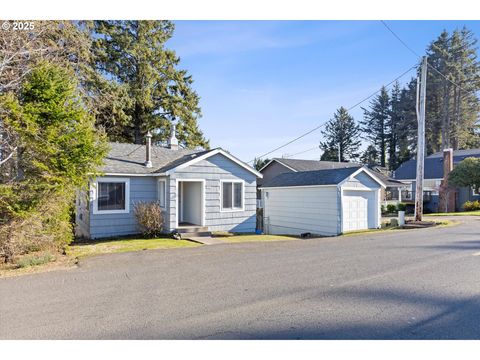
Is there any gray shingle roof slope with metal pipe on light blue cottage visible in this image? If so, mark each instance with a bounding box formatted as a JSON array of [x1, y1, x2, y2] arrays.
[[101, 143, 212, 174]]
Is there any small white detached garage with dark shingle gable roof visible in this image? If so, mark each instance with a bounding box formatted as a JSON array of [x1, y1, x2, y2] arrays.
[[260, 166, 384, 235]]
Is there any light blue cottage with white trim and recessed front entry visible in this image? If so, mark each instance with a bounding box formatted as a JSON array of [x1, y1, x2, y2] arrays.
[[76, 130, 262, 239]]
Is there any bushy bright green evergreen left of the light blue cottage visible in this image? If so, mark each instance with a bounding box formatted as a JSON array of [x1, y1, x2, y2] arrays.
[[0, 62, 108, 261]]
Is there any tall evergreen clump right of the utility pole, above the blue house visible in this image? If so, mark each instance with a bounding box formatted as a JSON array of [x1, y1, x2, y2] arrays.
[[426, 28, 480, 153]]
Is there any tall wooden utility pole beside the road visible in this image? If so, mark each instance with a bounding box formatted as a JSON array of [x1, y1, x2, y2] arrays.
[[415, 56, 427, 221]]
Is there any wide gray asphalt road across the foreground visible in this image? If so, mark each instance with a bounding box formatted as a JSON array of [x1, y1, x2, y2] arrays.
[[0, 217, 480, 339]]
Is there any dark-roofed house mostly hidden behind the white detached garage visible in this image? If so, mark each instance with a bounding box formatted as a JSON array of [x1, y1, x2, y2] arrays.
[[257, 158, 408, 207]]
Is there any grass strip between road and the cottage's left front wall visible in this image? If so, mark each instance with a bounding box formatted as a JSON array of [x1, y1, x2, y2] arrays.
[[67, 238, 201, 257]]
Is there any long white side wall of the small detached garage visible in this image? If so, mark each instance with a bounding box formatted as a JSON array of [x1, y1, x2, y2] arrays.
[[262, 186, 339, 235]]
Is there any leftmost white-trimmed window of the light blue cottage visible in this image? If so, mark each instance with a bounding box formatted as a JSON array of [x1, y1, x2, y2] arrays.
[[93, 178, 130, 214]]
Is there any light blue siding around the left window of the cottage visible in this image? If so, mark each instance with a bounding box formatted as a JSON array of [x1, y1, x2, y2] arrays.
[[90, 176, 158, 239]]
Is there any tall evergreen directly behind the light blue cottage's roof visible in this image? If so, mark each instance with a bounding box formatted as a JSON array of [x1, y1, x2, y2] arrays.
[[93, 21, 209, 148]]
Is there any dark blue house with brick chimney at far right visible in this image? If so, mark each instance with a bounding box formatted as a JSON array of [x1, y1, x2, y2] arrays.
[[393, 149, 480, 212]]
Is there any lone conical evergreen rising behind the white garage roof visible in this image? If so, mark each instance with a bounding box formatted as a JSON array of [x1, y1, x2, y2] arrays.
[[320, 107, 361, 162]]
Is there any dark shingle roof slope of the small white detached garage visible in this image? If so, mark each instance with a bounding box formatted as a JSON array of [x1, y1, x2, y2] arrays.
[[262, 166, 359, 187]]
